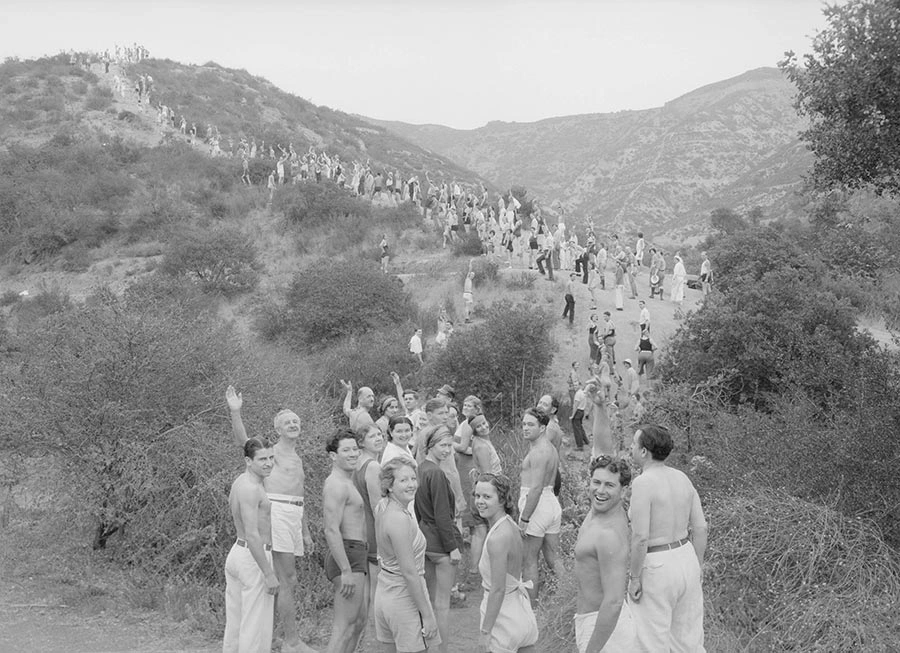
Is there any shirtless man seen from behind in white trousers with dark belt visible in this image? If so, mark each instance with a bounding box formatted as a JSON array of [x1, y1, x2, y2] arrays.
[[628, 424, 707, 653]]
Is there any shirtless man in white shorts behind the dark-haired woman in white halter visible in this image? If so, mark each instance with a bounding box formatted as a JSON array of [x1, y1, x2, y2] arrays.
[[519, 408, 565, 602]]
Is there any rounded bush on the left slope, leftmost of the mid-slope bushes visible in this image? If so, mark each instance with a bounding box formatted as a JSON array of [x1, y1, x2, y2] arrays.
[[160, 225, 263, 295]]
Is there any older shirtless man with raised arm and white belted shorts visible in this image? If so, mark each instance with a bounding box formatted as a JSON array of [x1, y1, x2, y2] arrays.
[[225, 386, 315, 653]]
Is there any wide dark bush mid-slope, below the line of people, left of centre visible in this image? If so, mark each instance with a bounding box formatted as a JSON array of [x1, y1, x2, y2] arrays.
[[269, 260, 415, 346]]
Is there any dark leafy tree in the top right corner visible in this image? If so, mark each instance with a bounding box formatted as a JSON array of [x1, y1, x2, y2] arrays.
[[779, 0, 900, 196]]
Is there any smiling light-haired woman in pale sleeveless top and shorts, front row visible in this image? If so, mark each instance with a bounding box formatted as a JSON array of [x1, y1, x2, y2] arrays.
[[375, 456, 441, 653]]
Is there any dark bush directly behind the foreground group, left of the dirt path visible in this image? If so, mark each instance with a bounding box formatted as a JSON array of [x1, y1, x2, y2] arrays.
[[429, 301, 555, 416]]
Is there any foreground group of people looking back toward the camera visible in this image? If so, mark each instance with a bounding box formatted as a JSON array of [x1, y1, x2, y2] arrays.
[[224, 366, 706, 653]]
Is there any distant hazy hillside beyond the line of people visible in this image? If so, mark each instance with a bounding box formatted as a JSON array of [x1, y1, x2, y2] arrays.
[[362, 68, 811, 240]]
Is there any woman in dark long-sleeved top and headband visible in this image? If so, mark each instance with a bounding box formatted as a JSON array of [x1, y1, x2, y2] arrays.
[[415, 425, 462, 653]]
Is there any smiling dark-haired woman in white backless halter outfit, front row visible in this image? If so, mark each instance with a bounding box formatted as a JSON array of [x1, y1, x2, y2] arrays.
[[475, 474, 538, 653]]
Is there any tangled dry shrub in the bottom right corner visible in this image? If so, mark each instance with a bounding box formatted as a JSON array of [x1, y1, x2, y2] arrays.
[[704, 489, 900, 653]]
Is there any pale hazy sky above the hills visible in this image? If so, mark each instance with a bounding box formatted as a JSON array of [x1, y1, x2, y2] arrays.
[[0, 0, 825, 129]]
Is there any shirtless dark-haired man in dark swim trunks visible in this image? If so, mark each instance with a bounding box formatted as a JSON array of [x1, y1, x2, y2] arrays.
[[322, 429, 369, 653]]
